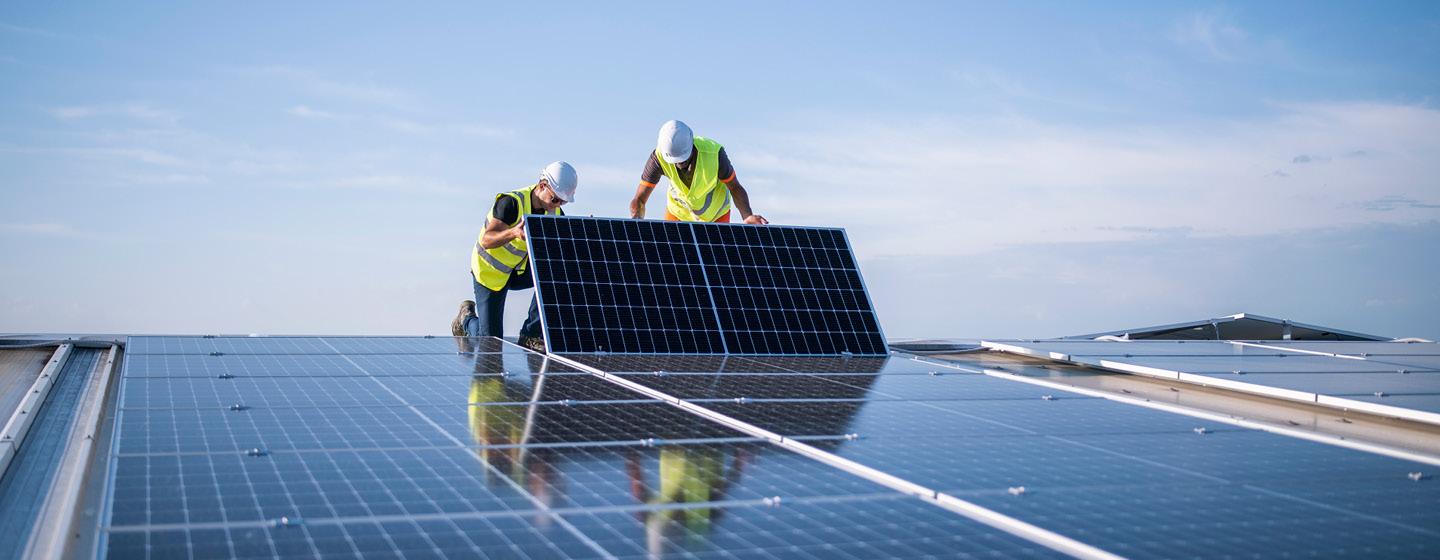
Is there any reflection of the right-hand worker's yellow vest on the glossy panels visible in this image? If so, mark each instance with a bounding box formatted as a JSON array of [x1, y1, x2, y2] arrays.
[[625, 445, 755, 554]]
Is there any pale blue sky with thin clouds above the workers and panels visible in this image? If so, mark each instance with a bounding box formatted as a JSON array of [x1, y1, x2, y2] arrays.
[[8, 1, 1440, 338]]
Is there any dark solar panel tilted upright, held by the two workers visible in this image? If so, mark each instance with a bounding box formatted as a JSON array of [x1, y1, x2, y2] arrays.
[[526, 216, 887, 356]]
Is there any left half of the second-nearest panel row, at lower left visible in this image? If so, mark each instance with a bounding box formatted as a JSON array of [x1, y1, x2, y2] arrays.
[[109, 449, 534, 525]]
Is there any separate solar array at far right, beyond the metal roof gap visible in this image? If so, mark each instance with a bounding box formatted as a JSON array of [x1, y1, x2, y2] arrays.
[[984, 340, 1440, 425]]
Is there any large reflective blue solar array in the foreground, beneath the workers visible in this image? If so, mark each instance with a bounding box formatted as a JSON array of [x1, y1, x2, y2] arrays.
[[90, 337, 1440, 559]]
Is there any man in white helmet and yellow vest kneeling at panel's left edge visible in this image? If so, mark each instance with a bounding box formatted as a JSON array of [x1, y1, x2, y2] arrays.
[[451, 161, 577, 353]]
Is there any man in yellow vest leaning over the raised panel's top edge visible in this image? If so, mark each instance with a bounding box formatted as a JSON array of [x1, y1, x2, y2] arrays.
[[631, 121, 770, 225]]
